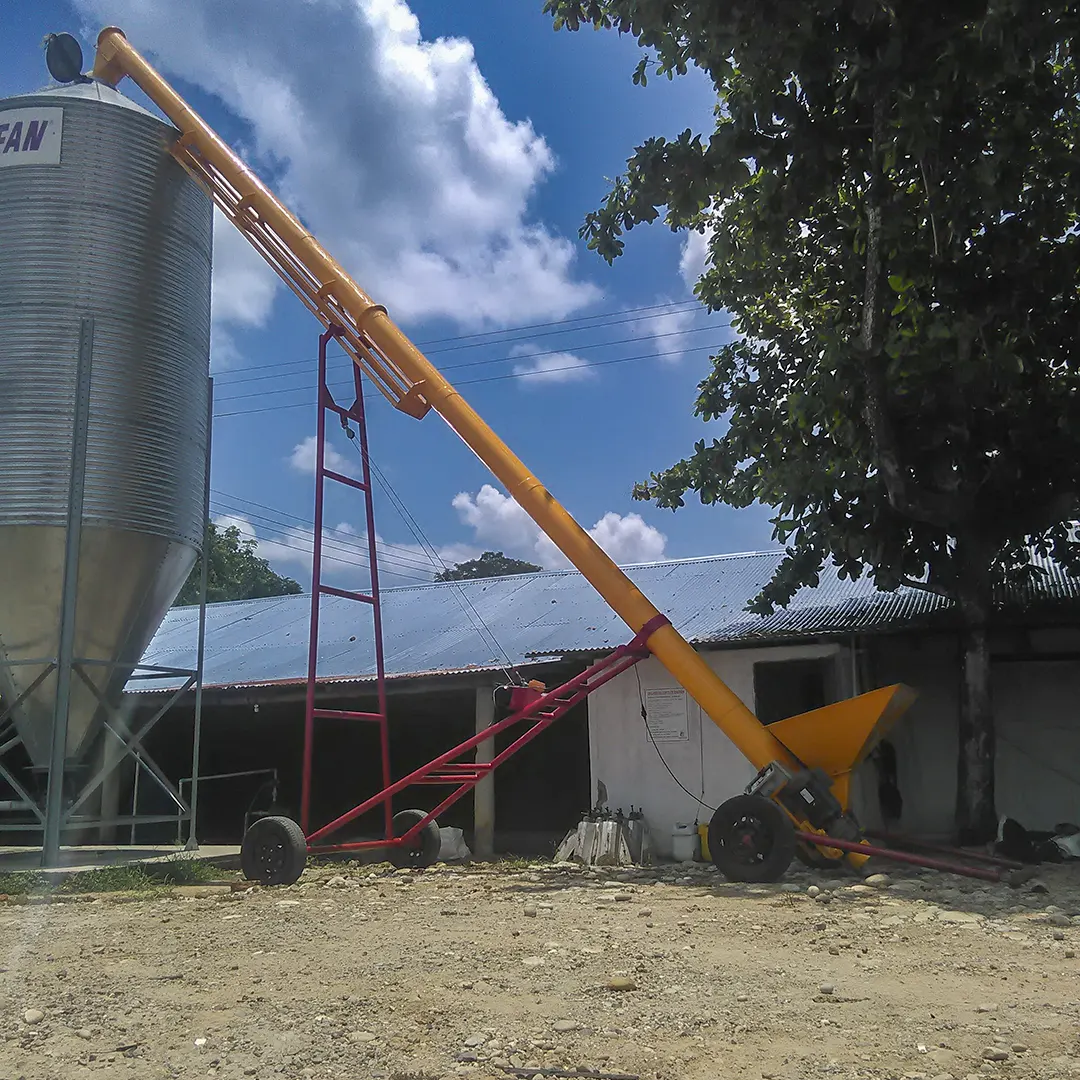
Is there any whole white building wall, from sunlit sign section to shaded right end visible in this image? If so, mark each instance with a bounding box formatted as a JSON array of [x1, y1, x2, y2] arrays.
[[589, 633, 1080, 856]]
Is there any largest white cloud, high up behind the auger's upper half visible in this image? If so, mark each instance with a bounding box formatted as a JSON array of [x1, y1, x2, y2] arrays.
[[76, 0, 598, 328]]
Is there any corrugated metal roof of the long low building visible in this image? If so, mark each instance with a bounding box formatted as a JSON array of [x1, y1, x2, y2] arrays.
[[130, 552, 1080, 690]]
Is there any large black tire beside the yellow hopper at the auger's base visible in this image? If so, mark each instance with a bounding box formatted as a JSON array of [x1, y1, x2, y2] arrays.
[[708, 795, 797, 881]]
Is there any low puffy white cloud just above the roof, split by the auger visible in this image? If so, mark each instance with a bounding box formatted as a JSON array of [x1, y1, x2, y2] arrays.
[[454, 484, 667, 569]]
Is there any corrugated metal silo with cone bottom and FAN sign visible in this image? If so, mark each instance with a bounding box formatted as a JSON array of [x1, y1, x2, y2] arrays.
[[0, 79, 213, 833]]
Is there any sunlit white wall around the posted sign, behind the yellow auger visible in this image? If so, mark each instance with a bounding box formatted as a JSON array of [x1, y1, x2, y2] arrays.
[[589, 645, 849, 856]]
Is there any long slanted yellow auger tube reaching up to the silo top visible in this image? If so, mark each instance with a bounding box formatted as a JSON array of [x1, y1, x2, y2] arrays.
[[94, 27, 885, 861]]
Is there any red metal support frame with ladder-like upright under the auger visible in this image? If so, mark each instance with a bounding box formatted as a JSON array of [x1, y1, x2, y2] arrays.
[[300, 326, 667, 854]]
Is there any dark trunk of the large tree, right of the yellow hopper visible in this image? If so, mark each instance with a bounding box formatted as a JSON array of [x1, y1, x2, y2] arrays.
[[956, 603, 998, 843]]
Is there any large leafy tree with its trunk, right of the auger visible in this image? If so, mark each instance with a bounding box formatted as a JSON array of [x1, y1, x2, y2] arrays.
[[545, 0, 1080, 840]]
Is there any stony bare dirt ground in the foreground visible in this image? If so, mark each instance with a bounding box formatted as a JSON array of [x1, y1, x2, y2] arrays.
[[0, 864, 1080, 1080]]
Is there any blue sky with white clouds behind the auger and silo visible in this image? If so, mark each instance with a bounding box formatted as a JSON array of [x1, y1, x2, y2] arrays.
[[0, 0, 771, 585]]
